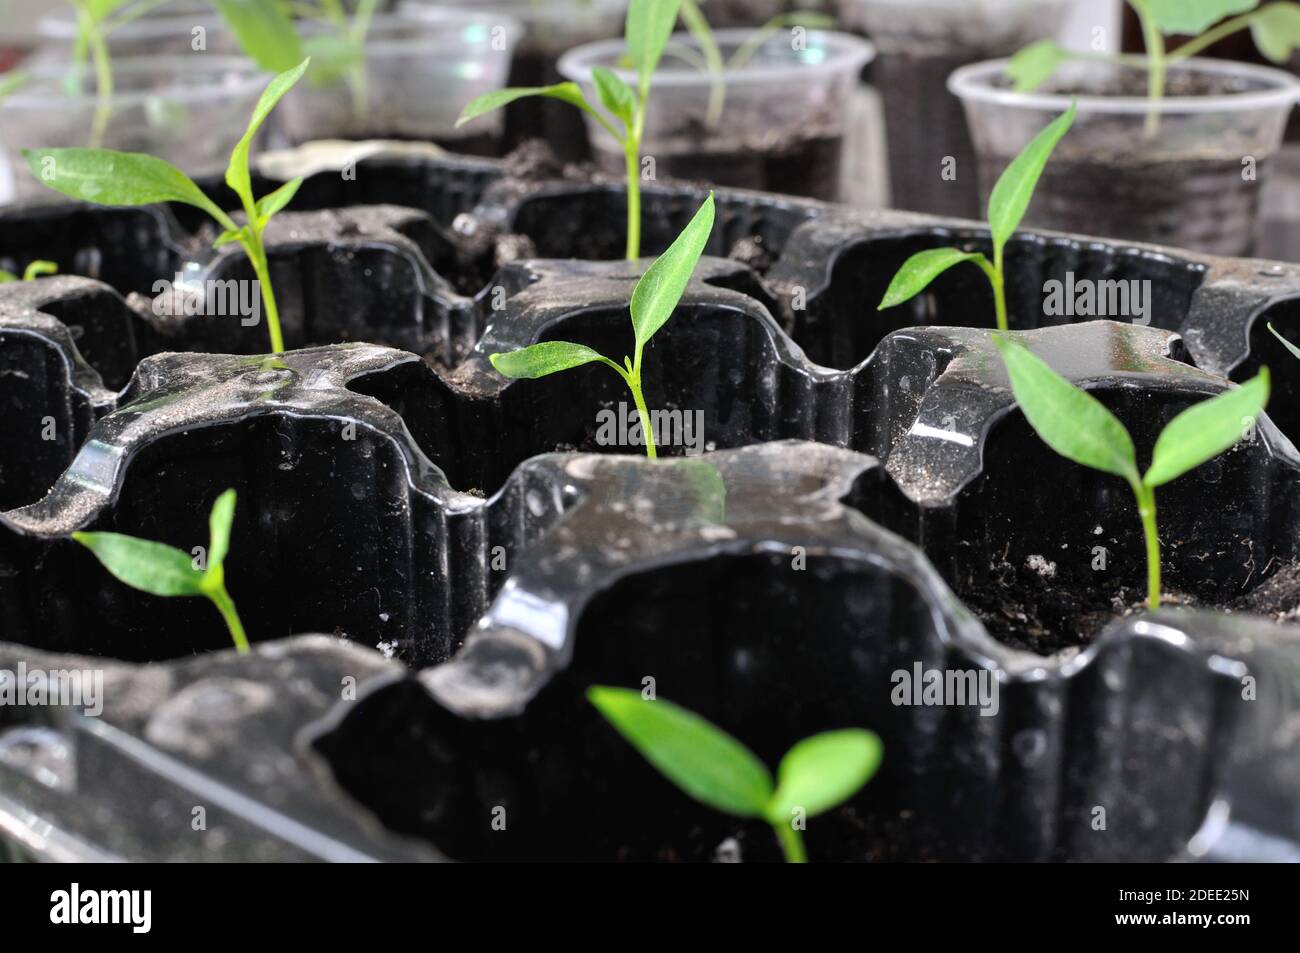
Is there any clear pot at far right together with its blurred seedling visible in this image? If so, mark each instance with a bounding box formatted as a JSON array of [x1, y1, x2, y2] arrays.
[[949, 0, 1300, 255]]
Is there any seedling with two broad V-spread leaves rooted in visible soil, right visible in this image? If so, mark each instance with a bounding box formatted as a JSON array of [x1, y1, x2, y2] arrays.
[[993, 334, 1269, 610]]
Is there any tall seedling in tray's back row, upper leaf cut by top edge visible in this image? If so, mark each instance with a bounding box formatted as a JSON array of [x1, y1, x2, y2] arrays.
[[456, 0, 681, 260]]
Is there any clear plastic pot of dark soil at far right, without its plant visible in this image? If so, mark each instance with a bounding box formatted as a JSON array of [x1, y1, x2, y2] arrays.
[[949, 59, 1300, 255]]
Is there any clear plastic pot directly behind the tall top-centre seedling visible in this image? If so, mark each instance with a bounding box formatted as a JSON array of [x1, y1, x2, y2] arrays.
[[560, 30, 874, 200]]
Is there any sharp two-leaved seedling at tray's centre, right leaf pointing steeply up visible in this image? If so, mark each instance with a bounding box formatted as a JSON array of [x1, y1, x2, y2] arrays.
[[489, 192, 714, 459]]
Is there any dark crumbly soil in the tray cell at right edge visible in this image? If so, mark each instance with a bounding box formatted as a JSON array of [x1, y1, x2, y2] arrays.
[[958, 563, 1300, 655]]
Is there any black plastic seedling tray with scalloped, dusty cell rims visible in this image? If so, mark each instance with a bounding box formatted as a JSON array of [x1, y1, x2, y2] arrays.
[[0, 152, 1300, 861]]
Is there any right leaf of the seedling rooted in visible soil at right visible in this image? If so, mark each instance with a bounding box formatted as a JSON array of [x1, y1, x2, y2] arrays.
[[1143, 368, 1269, 486]]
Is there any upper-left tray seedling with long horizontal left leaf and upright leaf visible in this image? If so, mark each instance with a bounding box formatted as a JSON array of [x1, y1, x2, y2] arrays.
[[22, 60, 311, 354]]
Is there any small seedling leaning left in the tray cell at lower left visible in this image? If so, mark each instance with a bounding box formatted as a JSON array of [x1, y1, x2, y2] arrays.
[[73, 490, 248, 655]]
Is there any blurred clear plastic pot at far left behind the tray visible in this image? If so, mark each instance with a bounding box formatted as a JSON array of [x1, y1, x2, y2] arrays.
[[0, 53, 269, 202]]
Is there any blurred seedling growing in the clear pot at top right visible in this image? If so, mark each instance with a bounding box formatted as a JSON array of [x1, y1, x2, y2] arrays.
[[1008, 0, 1300, 131]]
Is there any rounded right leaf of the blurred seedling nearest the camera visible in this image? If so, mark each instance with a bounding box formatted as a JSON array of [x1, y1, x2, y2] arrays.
[[766, 728, 883, 824]]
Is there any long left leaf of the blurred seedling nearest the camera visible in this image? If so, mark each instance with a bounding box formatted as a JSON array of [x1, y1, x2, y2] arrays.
[[586, 685, 772, 818]]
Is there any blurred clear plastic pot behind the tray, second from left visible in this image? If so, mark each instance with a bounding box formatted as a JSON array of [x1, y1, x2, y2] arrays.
[[280, 9, 521, 153]]
